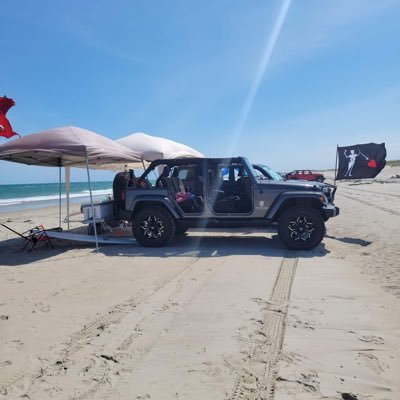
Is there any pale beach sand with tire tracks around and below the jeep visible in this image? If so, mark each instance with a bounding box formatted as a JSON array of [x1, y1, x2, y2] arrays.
[[0, 167, 400, 400]]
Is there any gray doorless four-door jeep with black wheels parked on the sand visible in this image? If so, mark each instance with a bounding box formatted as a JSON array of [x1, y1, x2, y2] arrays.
[[113, 157, 339, 250]]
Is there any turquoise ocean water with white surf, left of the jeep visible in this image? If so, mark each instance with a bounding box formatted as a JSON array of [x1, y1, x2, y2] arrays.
[[0, 181, 112, 213]]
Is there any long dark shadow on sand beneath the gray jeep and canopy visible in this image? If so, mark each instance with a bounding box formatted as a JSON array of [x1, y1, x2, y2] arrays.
[[0, 232, 329, 266]]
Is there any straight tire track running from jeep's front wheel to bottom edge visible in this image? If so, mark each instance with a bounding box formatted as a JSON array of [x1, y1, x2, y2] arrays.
[[230, 257, 298, 400]]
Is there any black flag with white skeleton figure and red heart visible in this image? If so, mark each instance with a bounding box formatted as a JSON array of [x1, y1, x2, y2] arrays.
[[336, 143, 386, 179]]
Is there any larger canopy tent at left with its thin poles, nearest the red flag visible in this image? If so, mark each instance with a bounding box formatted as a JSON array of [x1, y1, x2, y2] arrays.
[[0, 126, 141, 249]]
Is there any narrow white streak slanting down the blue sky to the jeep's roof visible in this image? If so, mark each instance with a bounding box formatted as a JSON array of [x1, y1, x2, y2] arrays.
[[228, 0, 292, 155]]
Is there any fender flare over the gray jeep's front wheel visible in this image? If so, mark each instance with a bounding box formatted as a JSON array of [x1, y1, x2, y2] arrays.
[[265, 192, 323, 220]]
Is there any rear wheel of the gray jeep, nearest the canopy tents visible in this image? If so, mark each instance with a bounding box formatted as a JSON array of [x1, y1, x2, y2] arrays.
[[132, 206, 175, 247]]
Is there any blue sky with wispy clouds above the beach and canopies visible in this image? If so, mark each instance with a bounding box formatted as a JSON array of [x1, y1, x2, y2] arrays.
[[0, 0, 400, 184]]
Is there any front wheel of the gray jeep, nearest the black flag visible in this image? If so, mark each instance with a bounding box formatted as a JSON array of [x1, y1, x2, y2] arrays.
[[278, 206, 325, 250]]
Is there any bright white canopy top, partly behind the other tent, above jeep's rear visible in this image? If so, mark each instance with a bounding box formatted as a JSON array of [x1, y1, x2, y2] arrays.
[[116, 132, 204, 161]]
